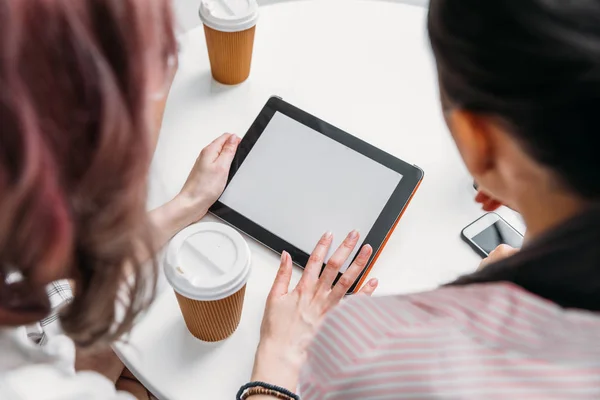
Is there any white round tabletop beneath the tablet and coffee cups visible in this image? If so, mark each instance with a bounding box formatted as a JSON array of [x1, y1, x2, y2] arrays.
[[116, 0, 523, 400]]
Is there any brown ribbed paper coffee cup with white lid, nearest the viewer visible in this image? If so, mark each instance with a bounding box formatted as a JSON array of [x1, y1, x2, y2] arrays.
[[165, 223, 250, 342]]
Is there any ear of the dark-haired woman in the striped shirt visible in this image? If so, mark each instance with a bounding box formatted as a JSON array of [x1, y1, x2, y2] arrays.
[[446, 109, 495, 179]]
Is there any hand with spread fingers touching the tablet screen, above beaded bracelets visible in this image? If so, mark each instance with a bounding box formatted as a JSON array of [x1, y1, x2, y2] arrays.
[[252, 231, 377, 392]]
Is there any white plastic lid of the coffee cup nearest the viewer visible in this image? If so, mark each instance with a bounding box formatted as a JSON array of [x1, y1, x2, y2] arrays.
[[165, 222, 250, 301]]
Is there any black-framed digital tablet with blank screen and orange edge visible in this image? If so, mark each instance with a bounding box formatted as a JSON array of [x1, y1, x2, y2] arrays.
[[210, 97, 423, 293]]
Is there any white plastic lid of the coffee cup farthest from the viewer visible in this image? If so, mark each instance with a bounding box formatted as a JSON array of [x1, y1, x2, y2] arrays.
[[198, 0, 258, 32]]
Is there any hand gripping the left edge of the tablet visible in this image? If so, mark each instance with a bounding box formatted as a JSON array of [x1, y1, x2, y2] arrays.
[[178, 133, 240, 223]]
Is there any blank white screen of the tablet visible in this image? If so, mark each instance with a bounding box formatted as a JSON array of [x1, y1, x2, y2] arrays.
[[220, 112, 402, 272]]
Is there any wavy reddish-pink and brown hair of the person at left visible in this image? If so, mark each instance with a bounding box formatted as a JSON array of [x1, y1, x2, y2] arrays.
[[0, 0, 176, 345]]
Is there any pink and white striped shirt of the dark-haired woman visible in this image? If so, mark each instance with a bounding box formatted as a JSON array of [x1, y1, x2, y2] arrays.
[[300, 283, 600, 400]]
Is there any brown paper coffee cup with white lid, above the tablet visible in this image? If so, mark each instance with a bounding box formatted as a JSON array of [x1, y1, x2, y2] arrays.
[[199, 0, 258, 85]]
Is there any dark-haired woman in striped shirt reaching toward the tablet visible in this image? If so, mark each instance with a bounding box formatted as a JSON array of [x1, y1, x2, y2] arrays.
[[241, 0, 600, 400]]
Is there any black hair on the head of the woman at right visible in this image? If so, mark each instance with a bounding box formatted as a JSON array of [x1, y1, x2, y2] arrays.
[[428, 0, 600, 201]]
